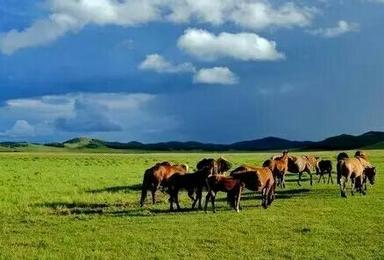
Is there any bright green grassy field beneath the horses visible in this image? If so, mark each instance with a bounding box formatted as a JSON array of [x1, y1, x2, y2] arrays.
[[0, 150, 384, 259]]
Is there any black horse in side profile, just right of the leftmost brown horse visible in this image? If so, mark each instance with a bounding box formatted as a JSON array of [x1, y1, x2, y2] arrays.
[[168, 167, 214, 211]]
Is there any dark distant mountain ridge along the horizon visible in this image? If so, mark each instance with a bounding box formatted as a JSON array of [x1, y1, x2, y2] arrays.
[[0, 131, 384, 151]]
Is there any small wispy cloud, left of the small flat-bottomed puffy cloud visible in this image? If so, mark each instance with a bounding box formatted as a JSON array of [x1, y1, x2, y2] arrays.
[[139, 53, 196, 73]]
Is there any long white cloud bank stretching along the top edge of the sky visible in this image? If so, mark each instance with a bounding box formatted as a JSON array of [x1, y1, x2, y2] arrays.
[[0, 0, 314, 54]]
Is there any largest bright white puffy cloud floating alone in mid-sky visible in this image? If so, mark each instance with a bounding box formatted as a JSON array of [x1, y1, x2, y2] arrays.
[[178, 29, 284, 61]]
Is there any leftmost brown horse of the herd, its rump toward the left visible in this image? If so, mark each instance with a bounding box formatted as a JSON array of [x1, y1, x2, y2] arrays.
[[140, 162, 188, 207]]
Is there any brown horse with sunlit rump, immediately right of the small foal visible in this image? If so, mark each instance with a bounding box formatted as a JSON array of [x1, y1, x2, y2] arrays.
[[231, 167, 276, 208]]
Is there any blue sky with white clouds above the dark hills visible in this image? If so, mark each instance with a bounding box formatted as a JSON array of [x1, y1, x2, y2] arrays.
[[0, 0, 384, 143]]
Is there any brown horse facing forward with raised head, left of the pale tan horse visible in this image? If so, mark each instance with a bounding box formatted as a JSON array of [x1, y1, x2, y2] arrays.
[[263, 151, 289, 188]]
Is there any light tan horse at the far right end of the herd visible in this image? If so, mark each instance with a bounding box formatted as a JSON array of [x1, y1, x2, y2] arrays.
[[339, 156, 376, 198]]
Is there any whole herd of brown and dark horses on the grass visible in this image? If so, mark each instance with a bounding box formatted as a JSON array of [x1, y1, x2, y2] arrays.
[[140, 151, 376, 212]]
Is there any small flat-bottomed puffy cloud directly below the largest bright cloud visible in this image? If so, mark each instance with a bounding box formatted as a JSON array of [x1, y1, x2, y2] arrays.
[[193, 67, 238, 85]]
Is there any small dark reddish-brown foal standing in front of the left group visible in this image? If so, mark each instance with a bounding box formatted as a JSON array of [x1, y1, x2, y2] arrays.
[[204, 175, 244, 213]]
